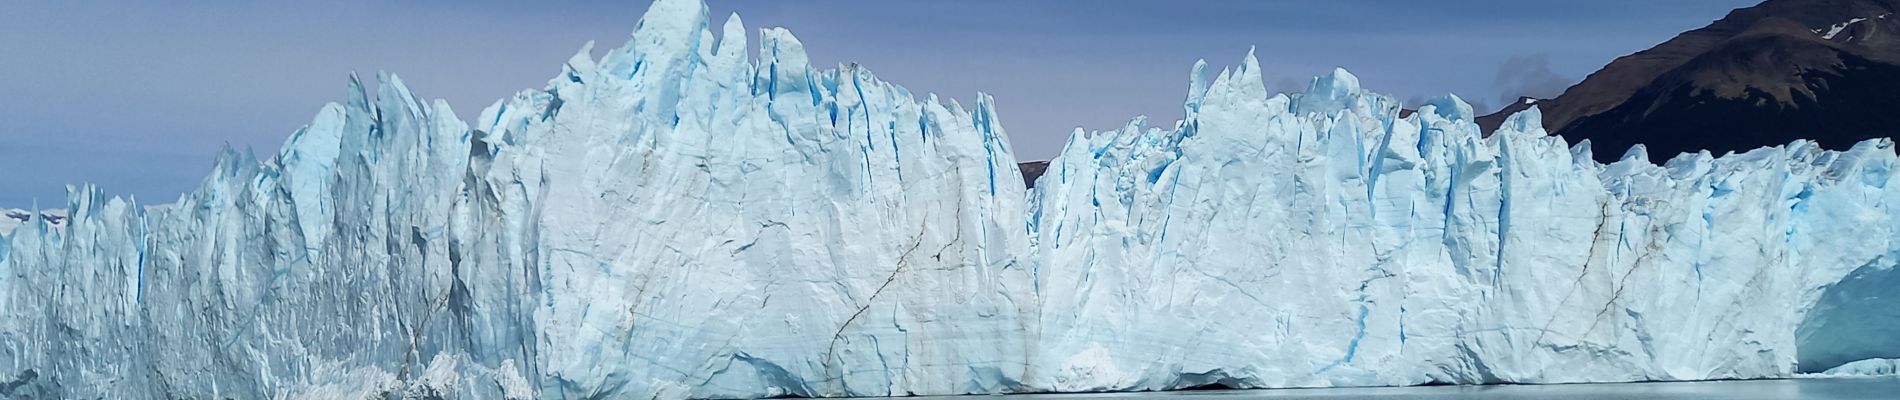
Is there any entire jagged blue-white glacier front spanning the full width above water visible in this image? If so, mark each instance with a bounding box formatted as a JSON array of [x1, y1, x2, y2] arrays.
[[0, 0, 1900, 398]]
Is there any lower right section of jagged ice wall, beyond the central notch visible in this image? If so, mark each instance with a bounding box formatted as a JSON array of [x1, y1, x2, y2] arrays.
[[1030, 61, 1900, 391]]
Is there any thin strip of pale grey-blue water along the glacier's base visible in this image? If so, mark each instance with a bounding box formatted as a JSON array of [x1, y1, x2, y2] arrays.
[[919, 377, 1900, 400]]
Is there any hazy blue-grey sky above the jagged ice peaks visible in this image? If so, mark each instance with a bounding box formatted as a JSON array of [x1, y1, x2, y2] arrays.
[[0, 0, 1754, 209]]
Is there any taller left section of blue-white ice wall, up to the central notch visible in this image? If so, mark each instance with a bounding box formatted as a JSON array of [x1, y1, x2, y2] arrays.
[[0, 0, 1034, 398]]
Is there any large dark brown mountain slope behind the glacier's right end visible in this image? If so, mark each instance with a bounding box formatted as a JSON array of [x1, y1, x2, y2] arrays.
[[1480, 0, 1900, 161]]
